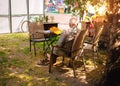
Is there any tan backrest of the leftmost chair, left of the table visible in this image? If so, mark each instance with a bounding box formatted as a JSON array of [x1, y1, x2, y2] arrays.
[[28, 22, 44, 38]]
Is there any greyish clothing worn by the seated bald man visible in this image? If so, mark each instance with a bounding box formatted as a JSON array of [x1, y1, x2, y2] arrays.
[[54, 28, 79, 55]]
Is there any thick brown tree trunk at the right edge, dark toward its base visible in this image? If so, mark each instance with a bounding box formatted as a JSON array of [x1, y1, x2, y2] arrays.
[[99, 0, 120, 86]]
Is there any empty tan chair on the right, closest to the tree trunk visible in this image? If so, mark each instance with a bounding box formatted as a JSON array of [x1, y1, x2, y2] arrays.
[[84, 25, 103, 67]]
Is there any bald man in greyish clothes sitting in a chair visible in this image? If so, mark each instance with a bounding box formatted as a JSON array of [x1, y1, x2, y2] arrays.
[[37, 17, 80, 64]]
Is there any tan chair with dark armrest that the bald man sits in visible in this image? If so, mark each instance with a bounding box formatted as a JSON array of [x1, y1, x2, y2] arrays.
[[49, 29, 88, 77]]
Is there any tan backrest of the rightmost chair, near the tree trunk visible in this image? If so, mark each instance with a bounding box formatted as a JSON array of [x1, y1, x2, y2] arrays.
[[93, 25, 104, 45]]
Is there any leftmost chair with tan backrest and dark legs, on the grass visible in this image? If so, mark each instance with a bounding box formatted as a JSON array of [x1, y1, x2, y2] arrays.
[[28, 22, 49, 56]]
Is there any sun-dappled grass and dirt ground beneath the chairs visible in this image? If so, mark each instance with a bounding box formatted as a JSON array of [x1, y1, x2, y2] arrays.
[[0, 33, 106, 86]]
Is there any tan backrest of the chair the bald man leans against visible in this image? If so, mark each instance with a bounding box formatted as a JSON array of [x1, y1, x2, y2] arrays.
[[71, 29, 88, 58]]
